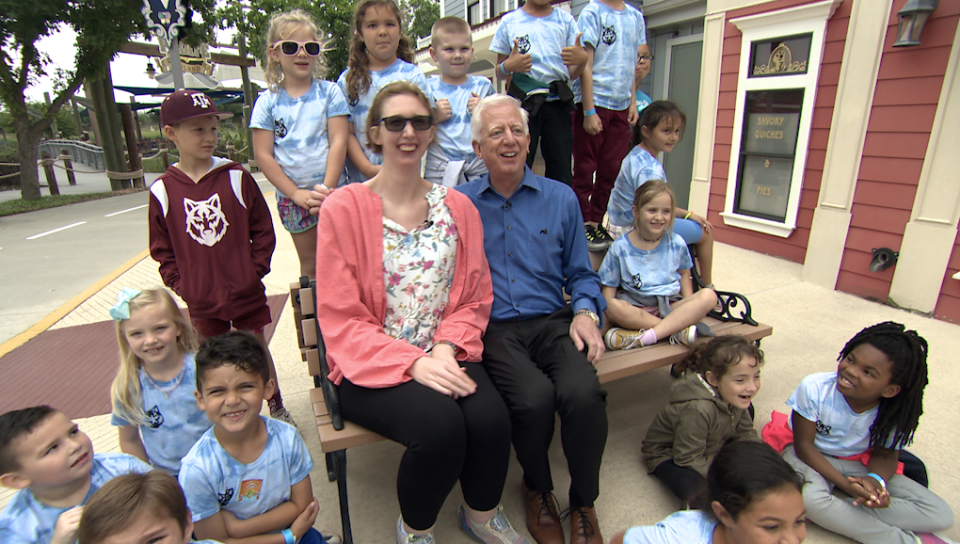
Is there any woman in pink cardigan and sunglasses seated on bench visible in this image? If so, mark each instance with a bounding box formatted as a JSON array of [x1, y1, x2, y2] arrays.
[[317, 81, 527, 544]]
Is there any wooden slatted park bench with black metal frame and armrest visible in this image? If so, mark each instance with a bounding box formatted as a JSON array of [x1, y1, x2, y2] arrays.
[[290, 278, 773, 544]]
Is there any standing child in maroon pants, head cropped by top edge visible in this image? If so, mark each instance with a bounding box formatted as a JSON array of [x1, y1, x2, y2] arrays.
[[573, 0, 650, 251]]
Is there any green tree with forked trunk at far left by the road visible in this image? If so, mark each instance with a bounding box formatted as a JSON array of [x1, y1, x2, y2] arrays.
[[0, 0, 214, 200]]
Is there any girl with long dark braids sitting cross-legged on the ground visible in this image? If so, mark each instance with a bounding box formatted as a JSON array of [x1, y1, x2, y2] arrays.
[[783, 321, 953, 544]]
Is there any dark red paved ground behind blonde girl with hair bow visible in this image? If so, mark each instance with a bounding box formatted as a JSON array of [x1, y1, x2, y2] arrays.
[[0, 295, 287, 418]]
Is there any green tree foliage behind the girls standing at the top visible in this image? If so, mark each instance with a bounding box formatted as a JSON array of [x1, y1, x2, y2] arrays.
[[216, 0, 440, 80]]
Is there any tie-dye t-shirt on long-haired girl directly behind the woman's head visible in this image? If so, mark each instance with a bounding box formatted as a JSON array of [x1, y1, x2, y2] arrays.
[[337, 59, 430, 183]]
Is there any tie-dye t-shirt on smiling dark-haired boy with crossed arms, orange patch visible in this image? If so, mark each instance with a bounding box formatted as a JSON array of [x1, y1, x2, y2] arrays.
[[179, 417, 313, 522]]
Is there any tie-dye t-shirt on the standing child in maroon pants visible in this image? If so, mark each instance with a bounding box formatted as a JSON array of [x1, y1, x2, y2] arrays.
[[573, 0, 647, 111]]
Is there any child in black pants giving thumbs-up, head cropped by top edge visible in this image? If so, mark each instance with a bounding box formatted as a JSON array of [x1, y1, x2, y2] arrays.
[[490, 0, 587, 185]]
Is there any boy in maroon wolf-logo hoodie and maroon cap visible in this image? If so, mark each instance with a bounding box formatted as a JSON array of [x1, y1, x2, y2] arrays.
[[149, 90, 293, 423]]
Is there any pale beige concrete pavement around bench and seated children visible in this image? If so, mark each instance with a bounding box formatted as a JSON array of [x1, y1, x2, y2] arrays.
[[0, 201, 960, 544]]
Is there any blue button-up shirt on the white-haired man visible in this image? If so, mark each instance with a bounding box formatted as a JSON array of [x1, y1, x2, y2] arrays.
[[456, 168, 607, 322]]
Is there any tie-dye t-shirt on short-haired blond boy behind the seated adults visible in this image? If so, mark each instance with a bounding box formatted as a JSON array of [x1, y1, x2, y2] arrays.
[[427, 76, 493, 161]]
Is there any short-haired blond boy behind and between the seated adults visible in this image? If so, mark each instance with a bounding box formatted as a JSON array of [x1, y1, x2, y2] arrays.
[[423, 17, 493, 187]]
